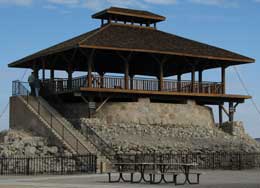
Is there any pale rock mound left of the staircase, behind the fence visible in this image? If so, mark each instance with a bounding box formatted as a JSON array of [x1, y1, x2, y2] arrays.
[[0, 130, 70, 157]]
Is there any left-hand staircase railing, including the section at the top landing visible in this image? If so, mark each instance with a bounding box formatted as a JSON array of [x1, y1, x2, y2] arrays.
[[12, 80, 90, 154]]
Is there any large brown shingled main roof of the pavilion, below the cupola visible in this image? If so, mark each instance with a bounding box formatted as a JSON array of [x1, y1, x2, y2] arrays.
[[9, 23, 255, 68]]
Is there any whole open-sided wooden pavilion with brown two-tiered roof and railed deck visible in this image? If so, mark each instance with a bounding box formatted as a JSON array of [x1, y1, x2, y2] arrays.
[[9, 7, 255, 123]]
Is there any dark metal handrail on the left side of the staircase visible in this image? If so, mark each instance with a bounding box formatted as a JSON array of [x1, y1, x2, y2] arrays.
[[12, 80, 90, 153]]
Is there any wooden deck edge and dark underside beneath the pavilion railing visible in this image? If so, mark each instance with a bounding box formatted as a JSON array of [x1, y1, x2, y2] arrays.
[[50, 87, 251, 105]]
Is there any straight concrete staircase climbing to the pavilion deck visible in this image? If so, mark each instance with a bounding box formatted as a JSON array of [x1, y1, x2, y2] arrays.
[[18, 96, 98, 155]]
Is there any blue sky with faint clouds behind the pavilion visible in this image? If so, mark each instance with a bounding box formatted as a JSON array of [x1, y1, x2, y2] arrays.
[[0, 0, 260, 137]]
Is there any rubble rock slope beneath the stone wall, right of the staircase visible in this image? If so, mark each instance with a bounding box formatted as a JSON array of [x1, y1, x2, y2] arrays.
[[81, 118, 260, 154]]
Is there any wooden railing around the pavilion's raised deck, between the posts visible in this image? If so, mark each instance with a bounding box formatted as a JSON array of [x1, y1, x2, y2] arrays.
[[44, 76, 223, 94]]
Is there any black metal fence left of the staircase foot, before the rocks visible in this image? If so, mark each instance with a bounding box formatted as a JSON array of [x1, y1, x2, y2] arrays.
[[0, 155, 97, 175]]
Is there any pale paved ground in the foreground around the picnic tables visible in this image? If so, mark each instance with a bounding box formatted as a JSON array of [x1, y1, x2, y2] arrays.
[[0, 170, 260, 188]]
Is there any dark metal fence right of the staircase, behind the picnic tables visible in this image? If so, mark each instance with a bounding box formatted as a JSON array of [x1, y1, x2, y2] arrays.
[[115, 153, 260, 170]]
